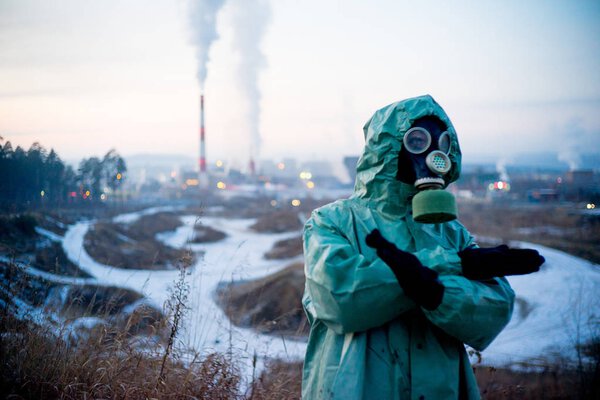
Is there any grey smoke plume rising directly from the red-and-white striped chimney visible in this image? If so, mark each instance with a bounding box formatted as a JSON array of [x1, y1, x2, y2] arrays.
[[190, 0, 225, 90]]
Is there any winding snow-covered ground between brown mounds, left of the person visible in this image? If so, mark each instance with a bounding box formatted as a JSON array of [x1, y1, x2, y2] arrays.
[[63, 212, 306, 382]]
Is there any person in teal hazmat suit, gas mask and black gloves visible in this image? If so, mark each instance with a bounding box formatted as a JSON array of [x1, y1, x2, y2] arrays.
[[302, 96, 544, 400]]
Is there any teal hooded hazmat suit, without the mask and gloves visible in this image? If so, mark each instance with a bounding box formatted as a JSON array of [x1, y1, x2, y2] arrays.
[[302, 96, 514, 400]]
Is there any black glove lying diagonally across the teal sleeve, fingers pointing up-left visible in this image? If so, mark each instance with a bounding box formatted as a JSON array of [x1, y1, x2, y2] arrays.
[[366, 229, 444, 310]]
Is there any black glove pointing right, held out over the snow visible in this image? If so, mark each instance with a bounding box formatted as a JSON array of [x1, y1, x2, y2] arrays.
[[458, 244, 546, 280]]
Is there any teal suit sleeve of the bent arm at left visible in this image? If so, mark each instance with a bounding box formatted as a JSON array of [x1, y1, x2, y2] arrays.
[[304, 210, 416, 334]]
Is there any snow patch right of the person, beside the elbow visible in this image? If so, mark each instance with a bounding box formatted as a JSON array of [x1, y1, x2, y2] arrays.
[[482, 242, 600, 365]]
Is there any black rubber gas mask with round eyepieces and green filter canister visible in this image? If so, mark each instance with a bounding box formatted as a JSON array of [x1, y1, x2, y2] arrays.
[[397, 117, 457, 224]]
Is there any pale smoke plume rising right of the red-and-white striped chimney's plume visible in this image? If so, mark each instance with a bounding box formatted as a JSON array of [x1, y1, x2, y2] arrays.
[[231, 0, 271, 164]]
